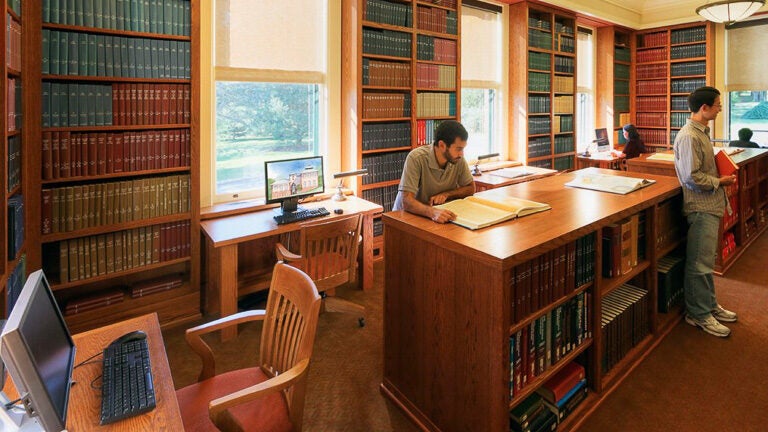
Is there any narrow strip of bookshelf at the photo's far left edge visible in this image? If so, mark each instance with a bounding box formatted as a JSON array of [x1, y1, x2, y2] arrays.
[[0, 0, 28, 316]]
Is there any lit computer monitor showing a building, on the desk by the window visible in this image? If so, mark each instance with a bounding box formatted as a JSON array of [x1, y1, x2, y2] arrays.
[[264, 156, 325, 213]]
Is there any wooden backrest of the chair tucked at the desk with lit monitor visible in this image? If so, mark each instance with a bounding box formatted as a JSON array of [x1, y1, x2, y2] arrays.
[[299, 214, 363, 292]]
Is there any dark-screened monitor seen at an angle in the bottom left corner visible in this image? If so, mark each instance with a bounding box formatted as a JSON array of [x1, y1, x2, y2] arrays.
[[0, 270, 75, 432]]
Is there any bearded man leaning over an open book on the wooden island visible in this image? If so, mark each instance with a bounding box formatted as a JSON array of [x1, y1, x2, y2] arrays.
[[392, 120, 475, 223]]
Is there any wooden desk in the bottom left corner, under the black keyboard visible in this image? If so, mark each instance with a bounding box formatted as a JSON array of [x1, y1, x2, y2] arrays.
[[6, 314, 184, 432]]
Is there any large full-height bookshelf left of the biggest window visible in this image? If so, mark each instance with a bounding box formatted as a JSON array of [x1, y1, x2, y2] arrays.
[[24, 0, 200, 332]]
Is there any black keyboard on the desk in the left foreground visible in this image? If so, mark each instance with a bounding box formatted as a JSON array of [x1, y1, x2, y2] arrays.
[[100, 332, 155, 425]]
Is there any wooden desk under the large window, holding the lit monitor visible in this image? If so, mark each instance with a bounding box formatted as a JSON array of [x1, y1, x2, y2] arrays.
[[200, 196, 384, 340]]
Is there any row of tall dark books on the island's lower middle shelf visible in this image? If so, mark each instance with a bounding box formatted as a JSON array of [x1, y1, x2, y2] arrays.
[[600, 284, 649, 373]]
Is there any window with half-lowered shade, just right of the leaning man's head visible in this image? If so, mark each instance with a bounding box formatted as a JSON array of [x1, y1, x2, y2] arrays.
[[461, 1, 508, 162]]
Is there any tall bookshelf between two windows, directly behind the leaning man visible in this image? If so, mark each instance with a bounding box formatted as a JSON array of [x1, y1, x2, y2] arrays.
[[342, 0, 461, 257]]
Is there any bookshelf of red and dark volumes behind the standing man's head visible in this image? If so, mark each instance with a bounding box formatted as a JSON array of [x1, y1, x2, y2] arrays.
[[633, 23, 714, 150]]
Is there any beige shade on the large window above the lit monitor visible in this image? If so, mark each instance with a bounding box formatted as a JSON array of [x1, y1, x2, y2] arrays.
[[214, 0, 328, 73]]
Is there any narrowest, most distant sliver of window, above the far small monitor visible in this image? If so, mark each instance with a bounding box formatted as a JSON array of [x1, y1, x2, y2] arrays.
[[576, 27, 592, 152]]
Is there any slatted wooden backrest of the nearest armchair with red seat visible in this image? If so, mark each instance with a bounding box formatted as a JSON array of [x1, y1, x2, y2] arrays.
[[259, 263, 321, 386]]
